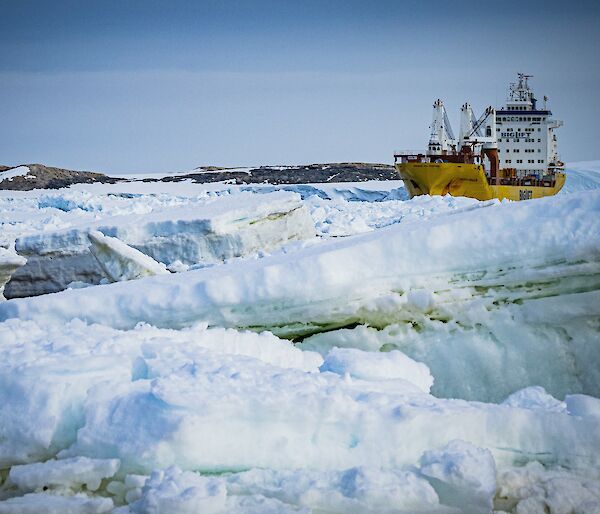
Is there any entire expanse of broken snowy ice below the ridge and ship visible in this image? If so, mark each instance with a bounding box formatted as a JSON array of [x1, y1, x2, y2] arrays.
[[0, 162, 600, 508]]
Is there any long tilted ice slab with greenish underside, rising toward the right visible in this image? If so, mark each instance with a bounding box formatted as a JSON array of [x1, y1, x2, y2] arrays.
[[0, 191, 600, 401]]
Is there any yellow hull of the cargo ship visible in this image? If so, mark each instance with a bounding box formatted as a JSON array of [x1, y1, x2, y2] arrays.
[[396, 162, 566, 200]]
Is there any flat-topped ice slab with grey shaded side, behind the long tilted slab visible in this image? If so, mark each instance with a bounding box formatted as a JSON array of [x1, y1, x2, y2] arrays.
[[7, 192, 315, 297]]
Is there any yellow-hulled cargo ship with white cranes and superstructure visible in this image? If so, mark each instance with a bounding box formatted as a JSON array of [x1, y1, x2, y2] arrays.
[[394, 73, 566, 200]]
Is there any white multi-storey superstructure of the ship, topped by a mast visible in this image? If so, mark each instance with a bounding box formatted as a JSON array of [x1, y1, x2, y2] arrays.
[[496, 73, 564, 178]]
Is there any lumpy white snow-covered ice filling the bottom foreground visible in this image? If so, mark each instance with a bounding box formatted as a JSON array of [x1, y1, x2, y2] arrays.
[[0, 320, 600, 513]]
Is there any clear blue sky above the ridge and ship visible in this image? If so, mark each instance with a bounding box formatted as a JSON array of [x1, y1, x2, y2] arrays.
[[0, 0, 600, 172]]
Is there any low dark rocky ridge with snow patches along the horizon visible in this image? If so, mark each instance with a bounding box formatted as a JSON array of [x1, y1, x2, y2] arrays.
[[0, 162, 398, 191]]
